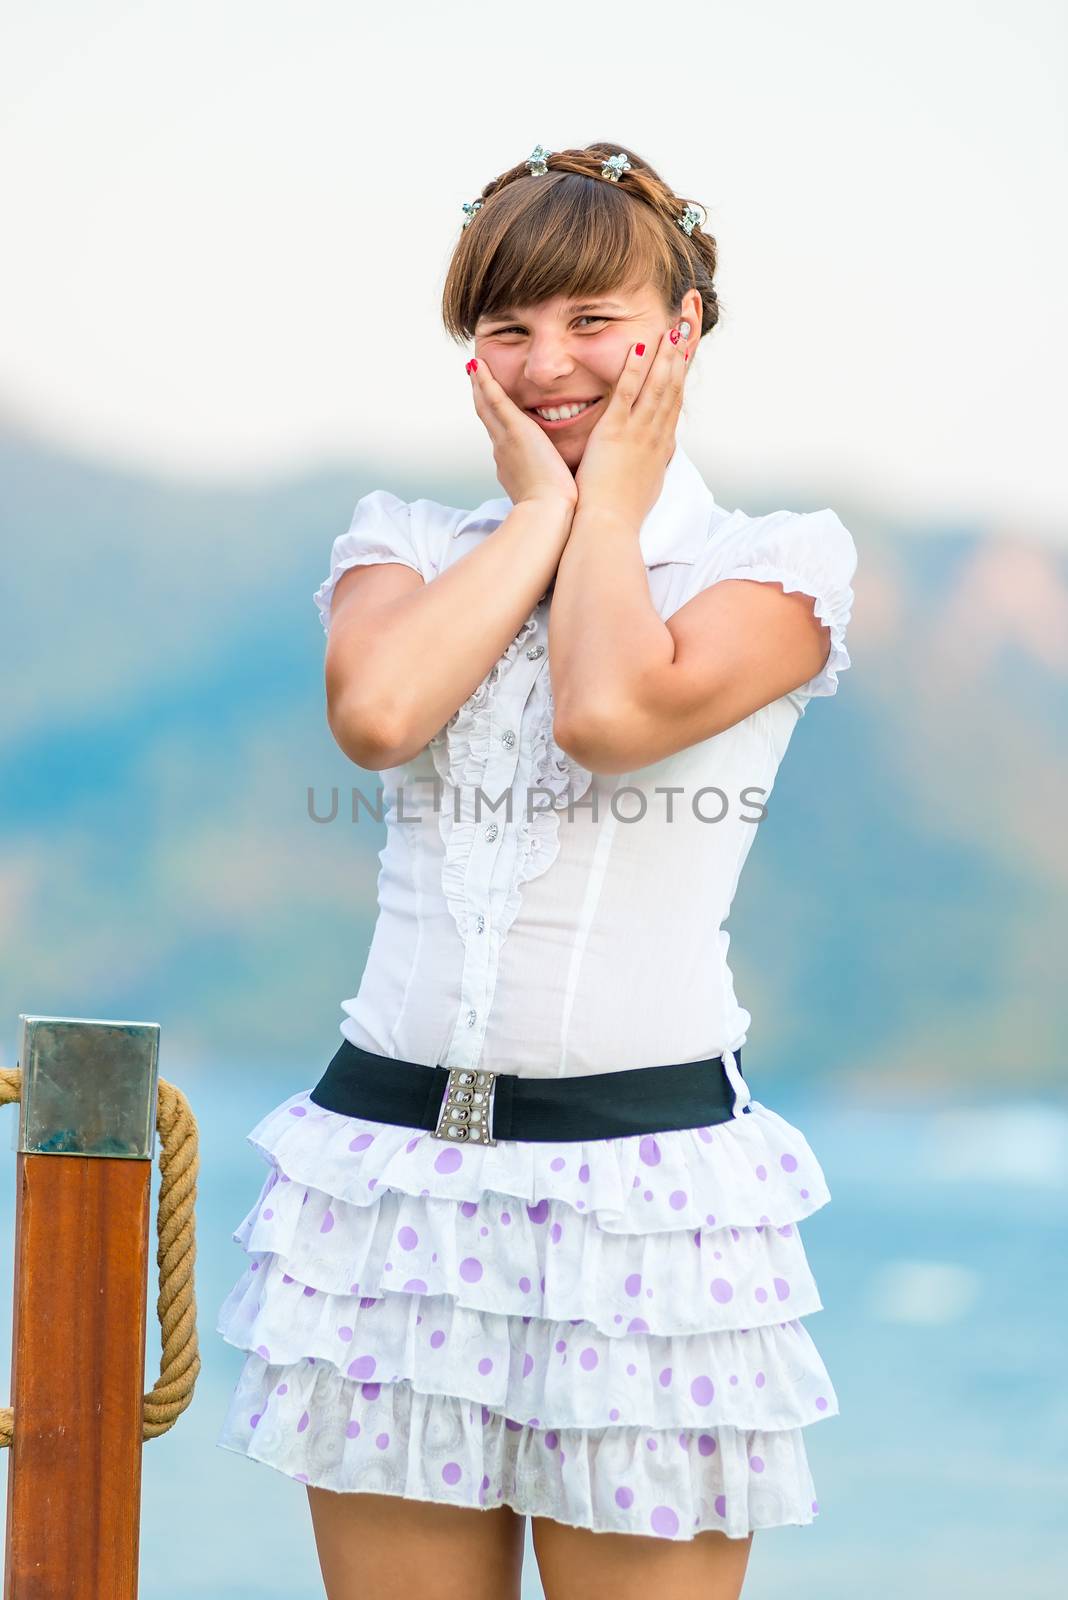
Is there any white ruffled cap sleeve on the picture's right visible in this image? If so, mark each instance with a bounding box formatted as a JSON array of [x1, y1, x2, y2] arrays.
[[715, 509, 857, 709]]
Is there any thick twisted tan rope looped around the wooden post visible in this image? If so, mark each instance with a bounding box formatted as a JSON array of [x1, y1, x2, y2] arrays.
[[0, 1067, 200, 1450]]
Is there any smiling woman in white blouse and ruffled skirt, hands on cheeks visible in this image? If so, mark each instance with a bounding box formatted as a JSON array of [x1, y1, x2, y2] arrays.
[[219, 144, 855, 1600]]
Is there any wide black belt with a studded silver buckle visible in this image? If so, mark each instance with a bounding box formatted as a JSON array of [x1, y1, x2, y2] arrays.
[[309, 1038, 750, 1144]]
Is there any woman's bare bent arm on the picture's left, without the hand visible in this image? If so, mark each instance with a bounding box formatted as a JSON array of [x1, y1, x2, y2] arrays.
[[326, 498, 574, 771]]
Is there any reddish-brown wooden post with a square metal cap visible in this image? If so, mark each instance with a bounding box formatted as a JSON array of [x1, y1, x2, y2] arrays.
[[3, 1016, 160, 1600]]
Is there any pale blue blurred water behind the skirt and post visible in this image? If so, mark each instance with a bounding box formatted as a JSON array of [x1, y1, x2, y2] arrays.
[[0, 1064, 1068, 1600]]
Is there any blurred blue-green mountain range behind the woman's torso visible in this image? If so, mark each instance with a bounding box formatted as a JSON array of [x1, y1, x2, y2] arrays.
[[0, 412, 1068, 1098]]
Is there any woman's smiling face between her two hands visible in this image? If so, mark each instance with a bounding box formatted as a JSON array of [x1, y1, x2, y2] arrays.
[[475, 285, 700, 470]]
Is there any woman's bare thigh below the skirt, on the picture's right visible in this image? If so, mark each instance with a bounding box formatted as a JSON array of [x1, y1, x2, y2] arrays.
[[531, 1517, 753, 1600]]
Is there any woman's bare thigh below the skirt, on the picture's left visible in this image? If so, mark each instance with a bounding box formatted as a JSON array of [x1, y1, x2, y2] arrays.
[[307, 1485, 526, 1600]]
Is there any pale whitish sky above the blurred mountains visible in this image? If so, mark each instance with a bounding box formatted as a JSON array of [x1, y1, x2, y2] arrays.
[[0, 0, 1068, 541]]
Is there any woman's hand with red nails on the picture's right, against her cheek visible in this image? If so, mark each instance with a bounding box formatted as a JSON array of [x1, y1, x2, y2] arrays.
[[576, 328, 686, 526]]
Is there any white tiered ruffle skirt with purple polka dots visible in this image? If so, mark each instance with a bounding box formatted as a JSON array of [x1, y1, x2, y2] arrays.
[[217, 1091, 838, 1539]]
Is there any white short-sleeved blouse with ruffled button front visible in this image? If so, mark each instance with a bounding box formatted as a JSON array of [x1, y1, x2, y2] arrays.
[[313, 443, 857, 1077]]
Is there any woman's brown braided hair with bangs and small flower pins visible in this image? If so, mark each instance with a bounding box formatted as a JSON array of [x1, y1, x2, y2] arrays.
[[441, 142, 719, 341]]
